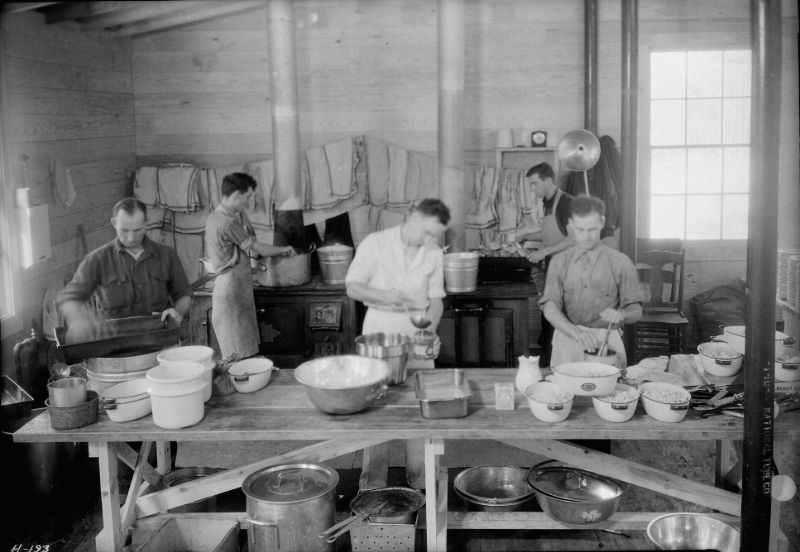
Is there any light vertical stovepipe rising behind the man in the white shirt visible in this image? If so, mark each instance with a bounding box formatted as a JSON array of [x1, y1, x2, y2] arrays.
[[437, 0, 467, 251]]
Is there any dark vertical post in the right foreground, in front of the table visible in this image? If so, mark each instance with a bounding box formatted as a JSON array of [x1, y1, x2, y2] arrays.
[[741, 0, 783, 550]]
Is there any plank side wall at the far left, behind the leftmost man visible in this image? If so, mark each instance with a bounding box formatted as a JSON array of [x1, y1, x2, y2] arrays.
[[2, 12, 136, 373]]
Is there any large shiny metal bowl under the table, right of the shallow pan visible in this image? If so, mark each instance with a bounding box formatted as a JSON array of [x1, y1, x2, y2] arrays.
[[528, 461, 625, 525]]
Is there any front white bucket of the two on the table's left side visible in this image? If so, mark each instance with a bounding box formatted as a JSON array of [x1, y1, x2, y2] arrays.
[[146, 361, 206, 429]]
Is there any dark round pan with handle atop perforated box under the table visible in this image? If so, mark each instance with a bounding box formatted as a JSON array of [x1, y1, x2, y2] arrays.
[[319, 487, 425, 543]]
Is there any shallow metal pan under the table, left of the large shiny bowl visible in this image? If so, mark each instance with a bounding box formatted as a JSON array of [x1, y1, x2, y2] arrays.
[[453, 466, 534, 512]]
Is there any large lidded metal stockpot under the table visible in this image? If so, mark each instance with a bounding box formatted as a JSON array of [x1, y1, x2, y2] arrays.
[[242, 464, 339, 552]]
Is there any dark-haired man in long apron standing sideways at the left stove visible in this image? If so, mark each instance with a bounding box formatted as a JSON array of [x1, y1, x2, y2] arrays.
[[205, 173, 294, 391]]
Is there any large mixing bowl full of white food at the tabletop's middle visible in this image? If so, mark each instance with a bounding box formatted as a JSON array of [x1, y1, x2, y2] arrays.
[[294, 355, 389, 414]]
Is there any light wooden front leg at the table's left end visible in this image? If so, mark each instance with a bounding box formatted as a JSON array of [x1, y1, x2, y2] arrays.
[[89, 441, 124, 552]]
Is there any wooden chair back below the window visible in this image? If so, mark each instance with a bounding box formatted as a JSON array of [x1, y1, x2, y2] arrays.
[[636, 249, 684, 313]]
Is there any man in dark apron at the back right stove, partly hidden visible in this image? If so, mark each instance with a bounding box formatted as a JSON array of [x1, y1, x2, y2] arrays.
[[517, 163, 575, 367]]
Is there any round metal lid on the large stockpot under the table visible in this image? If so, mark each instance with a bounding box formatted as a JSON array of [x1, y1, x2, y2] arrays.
[[242, 464, 339, 503]]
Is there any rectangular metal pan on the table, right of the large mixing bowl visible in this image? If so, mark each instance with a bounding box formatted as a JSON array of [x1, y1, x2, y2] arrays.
[[414, 368, 472, 418]]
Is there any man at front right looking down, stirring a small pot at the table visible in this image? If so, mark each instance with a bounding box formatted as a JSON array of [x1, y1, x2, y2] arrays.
[[539, 196, 643, 368]]
